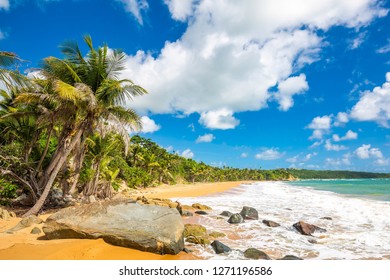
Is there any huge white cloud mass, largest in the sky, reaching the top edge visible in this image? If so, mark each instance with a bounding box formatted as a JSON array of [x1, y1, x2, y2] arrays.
[[122, 0, 386, 129]]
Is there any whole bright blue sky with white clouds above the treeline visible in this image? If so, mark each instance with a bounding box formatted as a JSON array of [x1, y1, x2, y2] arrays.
[[0, 0, 390, 172]]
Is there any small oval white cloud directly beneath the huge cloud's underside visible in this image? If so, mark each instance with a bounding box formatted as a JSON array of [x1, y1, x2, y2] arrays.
[[199, 109, 240, 130]]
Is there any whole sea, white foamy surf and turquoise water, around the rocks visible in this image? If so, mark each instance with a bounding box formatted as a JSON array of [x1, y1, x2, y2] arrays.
[[178, 179, 390, 260]]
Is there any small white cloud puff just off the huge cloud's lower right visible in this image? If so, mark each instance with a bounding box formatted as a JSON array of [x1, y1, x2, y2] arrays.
[[276, 74, 309, 111]]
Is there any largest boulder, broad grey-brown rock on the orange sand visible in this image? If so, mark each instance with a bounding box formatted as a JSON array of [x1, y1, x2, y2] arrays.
[[43, 200, 184, 254]]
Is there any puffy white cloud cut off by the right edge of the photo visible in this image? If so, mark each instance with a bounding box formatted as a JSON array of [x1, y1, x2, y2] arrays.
[[350, 72, 390, 127]]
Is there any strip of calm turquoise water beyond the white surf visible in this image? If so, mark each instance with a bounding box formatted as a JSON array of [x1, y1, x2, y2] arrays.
[[289, 178, 390, 201]]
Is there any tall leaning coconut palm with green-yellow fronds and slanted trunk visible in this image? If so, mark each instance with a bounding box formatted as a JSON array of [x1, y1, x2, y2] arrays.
[[15, 36, 146, 216]]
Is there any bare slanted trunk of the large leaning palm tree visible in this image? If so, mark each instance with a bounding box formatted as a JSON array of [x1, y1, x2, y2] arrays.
[[23, 129, 83, 217]]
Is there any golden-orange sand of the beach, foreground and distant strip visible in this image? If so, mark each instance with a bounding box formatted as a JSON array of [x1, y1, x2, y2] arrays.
[[0, 182, 244, 260]]
